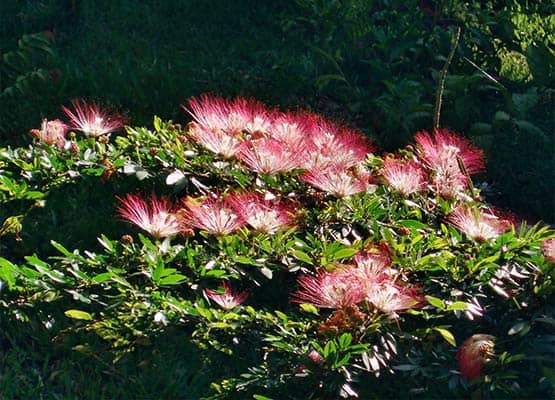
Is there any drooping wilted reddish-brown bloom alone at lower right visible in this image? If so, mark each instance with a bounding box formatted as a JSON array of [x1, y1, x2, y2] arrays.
[[457, 333, 495, 380]]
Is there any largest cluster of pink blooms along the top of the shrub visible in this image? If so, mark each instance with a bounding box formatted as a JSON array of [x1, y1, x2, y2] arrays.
[[183, 95, 374, 197]]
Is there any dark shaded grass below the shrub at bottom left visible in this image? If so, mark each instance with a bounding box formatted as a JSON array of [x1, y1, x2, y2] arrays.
[[0, 327, 219, 400]]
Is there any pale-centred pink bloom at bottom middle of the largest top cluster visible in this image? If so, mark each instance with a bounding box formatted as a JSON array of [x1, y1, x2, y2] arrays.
[[237, 137, 302, 174]]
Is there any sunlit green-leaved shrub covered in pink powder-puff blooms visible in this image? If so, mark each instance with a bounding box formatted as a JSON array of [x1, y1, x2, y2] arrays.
[[0, 95, 555, 399]]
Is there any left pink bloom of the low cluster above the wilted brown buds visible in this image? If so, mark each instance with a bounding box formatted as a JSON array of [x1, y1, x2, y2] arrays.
[[291, 270, 364, 309]]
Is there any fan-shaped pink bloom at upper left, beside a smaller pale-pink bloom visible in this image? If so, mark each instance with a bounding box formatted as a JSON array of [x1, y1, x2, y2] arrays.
[[62, 100, 124, 136]]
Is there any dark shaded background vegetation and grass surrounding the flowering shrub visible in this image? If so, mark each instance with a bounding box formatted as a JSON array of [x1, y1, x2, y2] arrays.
[[0, 0, 555, 398]]
